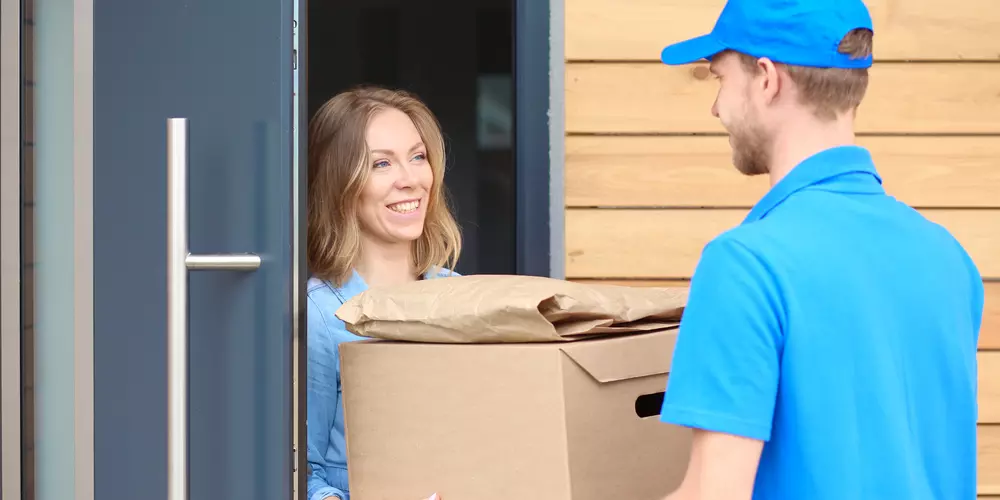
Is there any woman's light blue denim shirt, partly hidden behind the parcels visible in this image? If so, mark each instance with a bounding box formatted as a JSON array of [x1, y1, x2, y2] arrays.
[[306, 269, 458, 500]]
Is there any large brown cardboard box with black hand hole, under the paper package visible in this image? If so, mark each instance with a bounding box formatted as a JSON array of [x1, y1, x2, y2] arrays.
[[340, 329, 691, 500]]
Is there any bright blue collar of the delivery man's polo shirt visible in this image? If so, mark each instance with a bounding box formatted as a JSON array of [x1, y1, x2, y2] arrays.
[[743, 146, 885, 224]]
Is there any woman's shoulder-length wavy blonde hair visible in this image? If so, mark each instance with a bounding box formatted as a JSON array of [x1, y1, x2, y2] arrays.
[[306, 87, 462, 286]]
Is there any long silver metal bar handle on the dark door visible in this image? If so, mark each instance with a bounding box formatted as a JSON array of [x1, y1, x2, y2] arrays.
[[167, 118, 260, 500]]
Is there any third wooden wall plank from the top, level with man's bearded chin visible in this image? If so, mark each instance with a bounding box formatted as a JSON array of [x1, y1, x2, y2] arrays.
[[566, 136, 1000, 208]]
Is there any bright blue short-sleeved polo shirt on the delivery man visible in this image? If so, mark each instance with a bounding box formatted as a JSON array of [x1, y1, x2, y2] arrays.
[[661, 146, 983, 500]]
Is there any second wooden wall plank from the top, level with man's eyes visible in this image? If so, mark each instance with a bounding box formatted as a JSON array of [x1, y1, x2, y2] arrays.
[[565, 63, 1000, 134]]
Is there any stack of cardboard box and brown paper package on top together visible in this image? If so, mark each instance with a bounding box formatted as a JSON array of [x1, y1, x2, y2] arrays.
[[337, 276, 691, 500]]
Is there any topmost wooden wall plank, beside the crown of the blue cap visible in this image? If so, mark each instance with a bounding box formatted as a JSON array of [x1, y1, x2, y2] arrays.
[[565, 0, 1000, 61]]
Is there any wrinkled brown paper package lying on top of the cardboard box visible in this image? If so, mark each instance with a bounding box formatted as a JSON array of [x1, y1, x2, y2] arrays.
[[337, 275, 688, 343]]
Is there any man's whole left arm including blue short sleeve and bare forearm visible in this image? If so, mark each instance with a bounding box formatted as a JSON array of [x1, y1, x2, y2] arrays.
[[660, 235, 785, 500]]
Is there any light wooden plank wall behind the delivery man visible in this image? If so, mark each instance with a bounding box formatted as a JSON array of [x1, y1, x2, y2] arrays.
[[565, 0, 1000, 494]]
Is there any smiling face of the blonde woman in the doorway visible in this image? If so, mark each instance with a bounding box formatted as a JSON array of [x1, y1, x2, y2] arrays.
[[359, 109, 434, 244]]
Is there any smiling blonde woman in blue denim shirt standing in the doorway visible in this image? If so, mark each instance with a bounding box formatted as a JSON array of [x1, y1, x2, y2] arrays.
[[306, 88, 461, 500]]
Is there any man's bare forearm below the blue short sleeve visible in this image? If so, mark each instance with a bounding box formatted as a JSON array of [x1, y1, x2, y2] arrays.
[[664, 429, 764, 500]]
